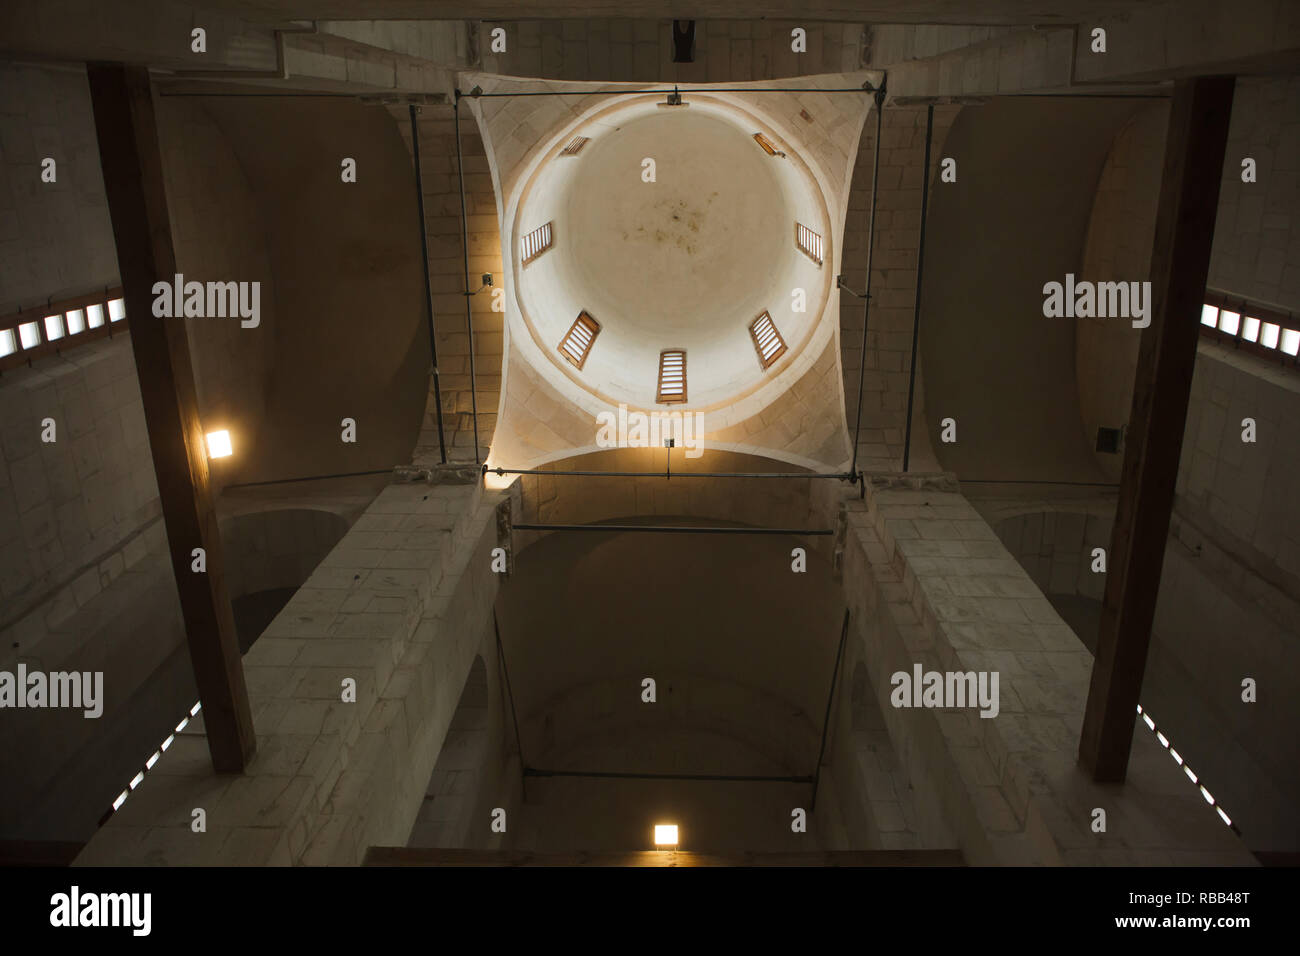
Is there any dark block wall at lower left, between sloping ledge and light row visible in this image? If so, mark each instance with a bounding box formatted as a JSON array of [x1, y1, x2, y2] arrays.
[[0, 519, 189, 842]]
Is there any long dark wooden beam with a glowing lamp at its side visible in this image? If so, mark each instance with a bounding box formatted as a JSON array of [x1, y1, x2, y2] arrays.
[[87, 64, 257, 773]]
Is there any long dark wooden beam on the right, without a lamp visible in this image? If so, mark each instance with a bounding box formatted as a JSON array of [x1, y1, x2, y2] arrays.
[[1079, 77, 1234, 783]]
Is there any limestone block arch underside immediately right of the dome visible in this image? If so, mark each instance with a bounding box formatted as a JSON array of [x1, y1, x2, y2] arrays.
[[840, 104, 961, 471]]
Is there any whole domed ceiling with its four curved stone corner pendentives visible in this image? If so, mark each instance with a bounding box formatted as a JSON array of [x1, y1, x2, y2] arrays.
[[460, 73, 880, 470]]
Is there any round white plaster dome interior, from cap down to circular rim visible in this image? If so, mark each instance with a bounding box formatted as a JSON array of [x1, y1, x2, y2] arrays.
[[515, 92, 826, 407]]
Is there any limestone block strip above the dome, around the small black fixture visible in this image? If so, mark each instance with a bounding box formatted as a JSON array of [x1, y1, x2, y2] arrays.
[[475, 18, 863, 83]]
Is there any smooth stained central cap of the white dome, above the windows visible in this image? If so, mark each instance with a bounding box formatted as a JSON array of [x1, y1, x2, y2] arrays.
[[564, 107, 790, 335]]
